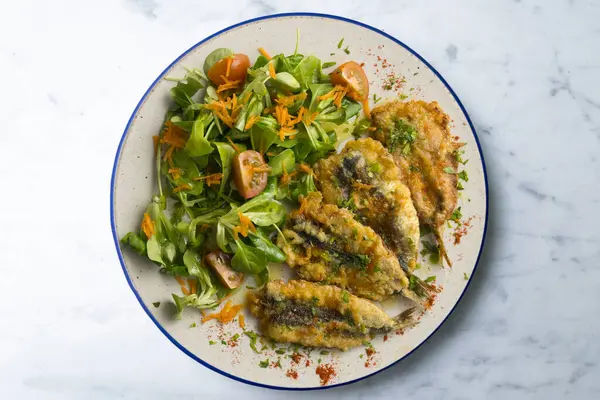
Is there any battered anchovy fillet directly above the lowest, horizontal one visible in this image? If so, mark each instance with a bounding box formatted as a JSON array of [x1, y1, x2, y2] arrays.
[[277, 192, 434, 305]]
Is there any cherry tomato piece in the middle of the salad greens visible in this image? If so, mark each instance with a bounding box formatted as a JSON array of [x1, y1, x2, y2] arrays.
[[233, 150, 269, 199]]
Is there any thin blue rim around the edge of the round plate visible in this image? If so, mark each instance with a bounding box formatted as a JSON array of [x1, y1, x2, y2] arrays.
[[110, 12, 489, 391]]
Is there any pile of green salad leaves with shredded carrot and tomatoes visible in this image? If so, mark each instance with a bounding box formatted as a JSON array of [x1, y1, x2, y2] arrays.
[[121, 43, 361, 316]]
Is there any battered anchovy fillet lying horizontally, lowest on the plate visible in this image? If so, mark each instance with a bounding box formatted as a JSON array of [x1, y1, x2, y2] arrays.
[[248, 280, 415, 350]]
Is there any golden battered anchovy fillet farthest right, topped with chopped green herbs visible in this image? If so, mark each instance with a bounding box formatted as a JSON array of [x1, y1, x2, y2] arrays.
[[371, 101, 463, 266]]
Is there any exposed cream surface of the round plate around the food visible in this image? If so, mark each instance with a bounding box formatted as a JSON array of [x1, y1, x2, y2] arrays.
[[111, 13, 487, 390]]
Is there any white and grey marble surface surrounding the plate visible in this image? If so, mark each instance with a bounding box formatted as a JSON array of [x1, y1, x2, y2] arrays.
[[0, 0, 600, 400]]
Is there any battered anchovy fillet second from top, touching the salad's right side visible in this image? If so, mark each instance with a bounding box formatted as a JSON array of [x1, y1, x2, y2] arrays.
[[314, 139, 419, 271]]
